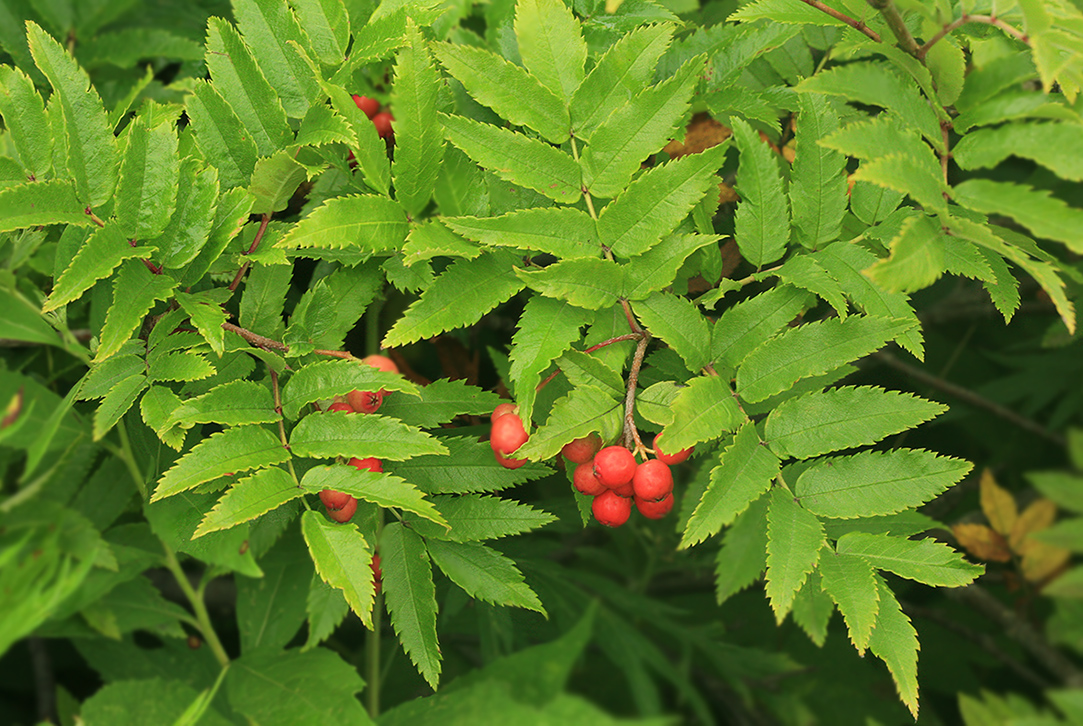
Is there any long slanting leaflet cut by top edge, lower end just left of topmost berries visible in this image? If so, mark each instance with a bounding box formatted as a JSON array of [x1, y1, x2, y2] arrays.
[[235, 0, 319, 118]]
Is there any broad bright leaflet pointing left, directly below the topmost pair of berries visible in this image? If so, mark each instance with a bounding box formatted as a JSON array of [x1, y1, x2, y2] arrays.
[[275, 194, 409, 252]]
